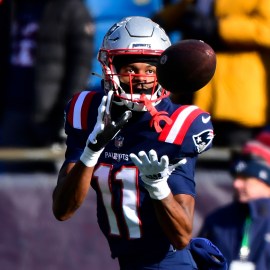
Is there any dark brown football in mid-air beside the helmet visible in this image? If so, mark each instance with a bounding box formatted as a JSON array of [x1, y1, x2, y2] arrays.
[[157, 39, 216, 93]]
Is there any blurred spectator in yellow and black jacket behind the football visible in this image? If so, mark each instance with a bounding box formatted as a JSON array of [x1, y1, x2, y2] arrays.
[[154, 0, 270, 147]]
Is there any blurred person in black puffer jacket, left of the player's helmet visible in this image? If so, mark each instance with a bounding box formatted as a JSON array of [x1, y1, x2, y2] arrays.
[[33, 0, 94, 147]]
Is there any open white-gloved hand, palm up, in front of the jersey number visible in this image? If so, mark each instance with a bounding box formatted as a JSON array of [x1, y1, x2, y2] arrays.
[[130, 149, 187, 200]]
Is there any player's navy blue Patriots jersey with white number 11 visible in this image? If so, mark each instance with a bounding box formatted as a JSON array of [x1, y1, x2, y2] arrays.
[[65, 91, 213, 257]]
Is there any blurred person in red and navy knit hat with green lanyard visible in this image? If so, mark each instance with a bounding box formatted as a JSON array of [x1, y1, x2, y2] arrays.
[[199, 131, 270, 270]]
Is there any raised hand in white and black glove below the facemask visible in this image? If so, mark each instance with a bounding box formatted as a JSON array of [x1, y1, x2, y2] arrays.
[[80, 91, 132, 167]]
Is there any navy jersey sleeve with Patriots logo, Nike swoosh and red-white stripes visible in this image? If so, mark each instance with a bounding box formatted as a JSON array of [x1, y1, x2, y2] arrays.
[[158, 105, 214, 197]]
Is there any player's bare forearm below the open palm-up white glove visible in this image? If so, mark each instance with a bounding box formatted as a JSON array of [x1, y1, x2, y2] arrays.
[[153, 193, 194, 249]]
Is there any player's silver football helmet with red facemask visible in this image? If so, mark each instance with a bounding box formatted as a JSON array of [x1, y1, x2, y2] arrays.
[[98, 16, 171, 111]]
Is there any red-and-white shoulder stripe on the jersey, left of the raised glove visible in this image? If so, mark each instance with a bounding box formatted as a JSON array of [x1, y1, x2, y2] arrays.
[[67, 91, 96, 130]]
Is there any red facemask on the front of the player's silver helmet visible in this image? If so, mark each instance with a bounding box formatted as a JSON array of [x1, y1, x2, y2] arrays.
[[100, 51, 169, 111]]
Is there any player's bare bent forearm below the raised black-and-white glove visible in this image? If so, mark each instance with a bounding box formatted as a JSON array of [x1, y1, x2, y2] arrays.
[[53, 161, 94, 221]]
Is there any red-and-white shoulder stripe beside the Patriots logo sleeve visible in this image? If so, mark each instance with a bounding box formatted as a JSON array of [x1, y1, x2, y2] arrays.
[[159, 105, 205, 145]]
